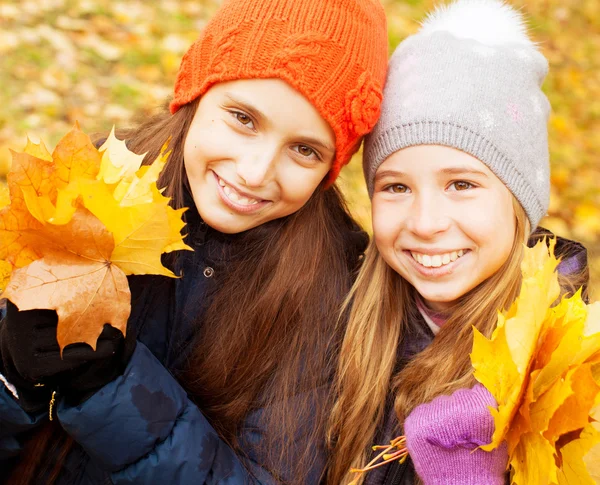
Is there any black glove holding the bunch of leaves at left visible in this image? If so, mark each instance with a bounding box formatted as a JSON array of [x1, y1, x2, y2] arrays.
[[0, 301, 136, 413]]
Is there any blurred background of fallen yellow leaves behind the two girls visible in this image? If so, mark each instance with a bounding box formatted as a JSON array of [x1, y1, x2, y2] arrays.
[[0, 0, 600, 299]]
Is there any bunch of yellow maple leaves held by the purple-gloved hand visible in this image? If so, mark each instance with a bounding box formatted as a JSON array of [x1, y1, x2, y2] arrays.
[[471, 240, 600, 485]]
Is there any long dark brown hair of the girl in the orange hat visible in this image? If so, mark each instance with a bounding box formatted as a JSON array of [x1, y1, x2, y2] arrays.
[[12, 100, 366, 483]]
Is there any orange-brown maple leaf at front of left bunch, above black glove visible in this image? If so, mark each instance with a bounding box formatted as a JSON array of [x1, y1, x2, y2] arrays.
[[3, 209, 131, 351]]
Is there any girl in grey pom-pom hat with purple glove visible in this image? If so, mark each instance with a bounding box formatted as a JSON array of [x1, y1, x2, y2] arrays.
[[329, 0, 587, 485]]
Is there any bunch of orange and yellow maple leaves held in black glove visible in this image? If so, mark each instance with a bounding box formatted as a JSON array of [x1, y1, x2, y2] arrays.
[[0, 126, 190, 349]]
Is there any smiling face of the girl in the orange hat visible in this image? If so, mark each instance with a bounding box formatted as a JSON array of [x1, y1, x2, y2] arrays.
[[184, 79, 335, 234]]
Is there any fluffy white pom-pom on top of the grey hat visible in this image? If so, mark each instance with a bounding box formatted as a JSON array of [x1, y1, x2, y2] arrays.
[[419, 0, 536, 48]]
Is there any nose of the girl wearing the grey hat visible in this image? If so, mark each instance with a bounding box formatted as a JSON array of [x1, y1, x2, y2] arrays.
[[407, 194, 451, 239]]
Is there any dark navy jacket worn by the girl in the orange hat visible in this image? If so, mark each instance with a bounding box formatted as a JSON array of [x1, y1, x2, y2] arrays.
[[0, 199, 367, 485]]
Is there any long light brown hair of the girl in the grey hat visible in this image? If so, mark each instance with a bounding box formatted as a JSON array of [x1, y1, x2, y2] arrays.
[[327, 199, 583, 485]]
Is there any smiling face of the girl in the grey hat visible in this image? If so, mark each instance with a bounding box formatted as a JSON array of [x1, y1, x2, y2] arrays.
[[372, 145, 516, 310]]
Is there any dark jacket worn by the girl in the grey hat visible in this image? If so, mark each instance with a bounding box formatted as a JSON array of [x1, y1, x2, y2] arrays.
[[364, 228, 587, 485]]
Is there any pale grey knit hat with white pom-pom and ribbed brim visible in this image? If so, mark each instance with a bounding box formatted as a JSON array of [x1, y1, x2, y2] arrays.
[[363, 0, 550, 230]]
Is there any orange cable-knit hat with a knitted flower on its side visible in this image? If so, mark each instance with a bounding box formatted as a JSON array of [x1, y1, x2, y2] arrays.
[[170, 0, 388, 183]]
